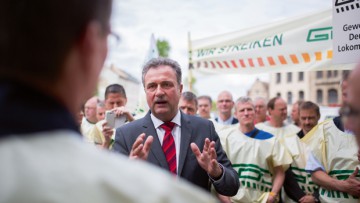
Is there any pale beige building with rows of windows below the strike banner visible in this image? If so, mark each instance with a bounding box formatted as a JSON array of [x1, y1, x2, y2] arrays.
[[269, 70, 347, 106]]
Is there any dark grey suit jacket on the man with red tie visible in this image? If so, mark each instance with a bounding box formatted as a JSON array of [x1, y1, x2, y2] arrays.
[[113, 112, 240, 196]]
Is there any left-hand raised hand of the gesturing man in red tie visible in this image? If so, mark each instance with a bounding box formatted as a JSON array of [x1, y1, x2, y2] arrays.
[[129, 133, 154, 160]]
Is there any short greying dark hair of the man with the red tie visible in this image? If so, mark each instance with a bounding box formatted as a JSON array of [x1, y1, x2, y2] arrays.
[[142, 57, 181, 87]]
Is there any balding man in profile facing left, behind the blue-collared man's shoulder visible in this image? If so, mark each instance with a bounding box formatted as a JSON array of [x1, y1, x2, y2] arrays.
[[256, 97, 300, 139]]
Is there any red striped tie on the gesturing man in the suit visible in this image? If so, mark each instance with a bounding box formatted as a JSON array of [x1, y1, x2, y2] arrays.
[[160, 122, 177, 174]]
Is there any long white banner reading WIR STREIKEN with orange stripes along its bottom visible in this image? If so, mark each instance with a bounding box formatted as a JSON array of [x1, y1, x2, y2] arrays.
[[191, 9, 354, 74]]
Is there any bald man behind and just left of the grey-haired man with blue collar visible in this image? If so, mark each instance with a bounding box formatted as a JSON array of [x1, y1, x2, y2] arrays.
[[215, 91, 239, 125]]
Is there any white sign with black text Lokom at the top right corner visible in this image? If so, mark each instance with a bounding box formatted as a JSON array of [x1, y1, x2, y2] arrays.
[[333, 0, 360, 64]]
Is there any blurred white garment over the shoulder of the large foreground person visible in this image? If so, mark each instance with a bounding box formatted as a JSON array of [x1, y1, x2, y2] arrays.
[[0, 131, 216, 203]]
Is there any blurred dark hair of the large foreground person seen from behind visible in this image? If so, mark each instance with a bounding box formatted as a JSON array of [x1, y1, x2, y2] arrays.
[[0, 0, 112, 82]]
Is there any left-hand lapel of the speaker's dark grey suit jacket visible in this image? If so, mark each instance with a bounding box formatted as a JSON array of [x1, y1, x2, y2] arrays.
[[143, 111, 169, 168]]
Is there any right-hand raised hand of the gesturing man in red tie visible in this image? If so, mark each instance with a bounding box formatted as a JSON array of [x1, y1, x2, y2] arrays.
[[190, 138, 222, 180]]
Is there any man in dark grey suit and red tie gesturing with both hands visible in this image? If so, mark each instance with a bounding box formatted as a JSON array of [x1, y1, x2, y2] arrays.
[[114, 58, 239, 196]]
